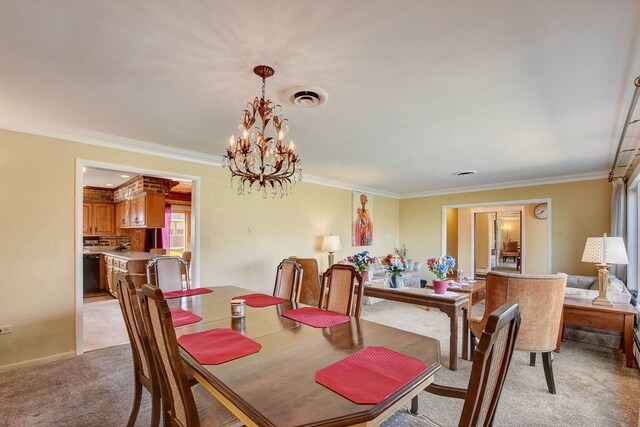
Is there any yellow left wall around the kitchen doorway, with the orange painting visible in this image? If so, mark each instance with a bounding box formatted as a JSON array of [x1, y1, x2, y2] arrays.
[[0, 130, 399, 369]]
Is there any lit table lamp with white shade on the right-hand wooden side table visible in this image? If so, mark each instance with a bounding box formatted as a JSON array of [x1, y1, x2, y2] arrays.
[[582, 233, 629, 306]]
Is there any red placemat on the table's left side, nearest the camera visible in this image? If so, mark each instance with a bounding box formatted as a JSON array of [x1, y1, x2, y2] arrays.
[[178, 328, 262, 365]]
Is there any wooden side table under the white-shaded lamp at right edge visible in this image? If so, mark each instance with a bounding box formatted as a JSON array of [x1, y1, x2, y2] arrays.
[[556, 297, 638, 368]]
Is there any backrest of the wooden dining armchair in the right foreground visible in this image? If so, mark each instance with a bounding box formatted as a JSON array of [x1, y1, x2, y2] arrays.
[[458, 303, 520, 427]]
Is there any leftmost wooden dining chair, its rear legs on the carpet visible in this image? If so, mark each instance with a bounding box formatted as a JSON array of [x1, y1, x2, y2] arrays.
[[114, 272, 160, 427]]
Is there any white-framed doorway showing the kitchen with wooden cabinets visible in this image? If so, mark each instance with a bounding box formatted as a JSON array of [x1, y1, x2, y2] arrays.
[[76, 160, 199, 355]]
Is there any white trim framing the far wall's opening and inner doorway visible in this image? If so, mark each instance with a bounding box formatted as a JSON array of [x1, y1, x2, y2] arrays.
[[440, 197, 553, 274]]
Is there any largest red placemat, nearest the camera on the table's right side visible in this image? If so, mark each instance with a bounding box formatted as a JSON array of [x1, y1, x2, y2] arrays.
[[316, 347, 427, 405]]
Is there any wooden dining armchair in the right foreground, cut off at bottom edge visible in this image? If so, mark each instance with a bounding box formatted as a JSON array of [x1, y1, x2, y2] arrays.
[[382, 302, 520, 427]]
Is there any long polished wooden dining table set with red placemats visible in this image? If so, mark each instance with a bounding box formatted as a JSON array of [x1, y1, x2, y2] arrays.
[[167, 286, 440, 426]]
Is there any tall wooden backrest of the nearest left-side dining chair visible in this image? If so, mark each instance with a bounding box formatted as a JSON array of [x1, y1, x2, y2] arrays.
[[141, 285, 200, 427]]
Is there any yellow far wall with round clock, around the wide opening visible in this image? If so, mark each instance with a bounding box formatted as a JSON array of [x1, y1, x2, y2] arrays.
[[400, 179, 611, 277]]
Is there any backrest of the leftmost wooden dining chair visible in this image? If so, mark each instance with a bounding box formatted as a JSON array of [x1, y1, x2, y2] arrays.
[[114, 272, 156, 390]]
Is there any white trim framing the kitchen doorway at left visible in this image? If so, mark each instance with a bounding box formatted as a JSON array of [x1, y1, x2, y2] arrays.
[[75, 159, 201, 355]]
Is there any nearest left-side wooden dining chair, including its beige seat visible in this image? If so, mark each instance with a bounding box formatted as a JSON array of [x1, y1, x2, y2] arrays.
[[141, 285, 242, 427]]
